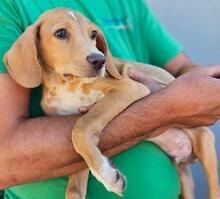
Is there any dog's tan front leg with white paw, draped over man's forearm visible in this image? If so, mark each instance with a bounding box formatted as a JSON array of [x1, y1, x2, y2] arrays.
[[72, 78, 150, 195]]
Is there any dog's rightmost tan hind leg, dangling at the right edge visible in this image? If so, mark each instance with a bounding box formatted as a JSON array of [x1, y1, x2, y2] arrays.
[[186, 127, 220, 199]]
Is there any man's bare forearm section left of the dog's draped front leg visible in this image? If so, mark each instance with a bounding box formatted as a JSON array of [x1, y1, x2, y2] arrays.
[[0, 116, 80, 186]]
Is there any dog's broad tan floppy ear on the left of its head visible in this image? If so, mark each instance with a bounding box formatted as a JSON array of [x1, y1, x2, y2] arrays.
[[4, 25, 42, 88]]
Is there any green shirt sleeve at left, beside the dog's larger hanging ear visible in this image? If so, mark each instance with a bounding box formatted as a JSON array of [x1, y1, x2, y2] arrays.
[[0, 0, 23, 73]]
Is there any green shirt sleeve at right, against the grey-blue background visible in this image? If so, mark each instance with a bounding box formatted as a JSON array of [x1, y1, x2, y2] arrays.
[[138, 0, 183, 66]]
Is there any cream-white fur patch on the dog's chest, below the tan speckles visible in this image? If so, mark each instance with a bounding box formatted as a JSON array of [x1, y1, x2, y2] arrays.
[[41, 86, 104, 115]]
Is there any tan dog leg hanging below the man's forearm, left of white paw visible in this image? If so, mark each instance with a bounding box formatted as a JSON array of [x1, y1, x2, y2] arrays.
[[66, 169, 89, 199]]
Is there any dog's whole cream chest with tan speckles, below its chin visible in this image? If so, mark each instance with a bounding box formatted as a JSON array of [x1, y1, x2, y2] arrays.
[[41, 77, 105, 115]]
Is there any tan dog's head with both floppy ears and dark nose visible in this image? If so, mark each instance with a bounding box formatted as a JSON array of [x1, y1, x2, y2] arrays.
[[4, 9, 121, 88]]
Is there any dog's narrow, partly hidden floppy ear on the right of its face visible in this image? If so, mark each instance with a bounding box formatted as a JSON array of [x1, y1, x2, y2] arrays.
[[96, 29, 122, 79]]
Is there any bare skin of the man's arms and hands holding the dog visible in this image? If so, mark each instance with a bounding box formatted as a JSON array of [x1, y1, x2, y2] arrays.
[[0, 53, 220, 189]]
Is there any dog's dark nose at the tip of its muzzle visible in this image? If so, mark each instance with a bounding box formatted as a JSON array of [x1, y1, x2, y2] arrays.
[[86, 53, 105, 71]]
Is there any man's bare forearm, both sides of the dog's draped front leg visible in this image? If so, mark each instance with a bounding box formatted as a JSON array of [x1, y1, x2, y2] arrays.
[[0, 91, 169, 186]]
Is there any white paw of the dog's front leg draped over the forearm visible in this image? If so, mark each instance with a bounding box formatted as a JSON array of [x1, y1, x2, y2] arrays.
[[90, 158, 126, 196]]
